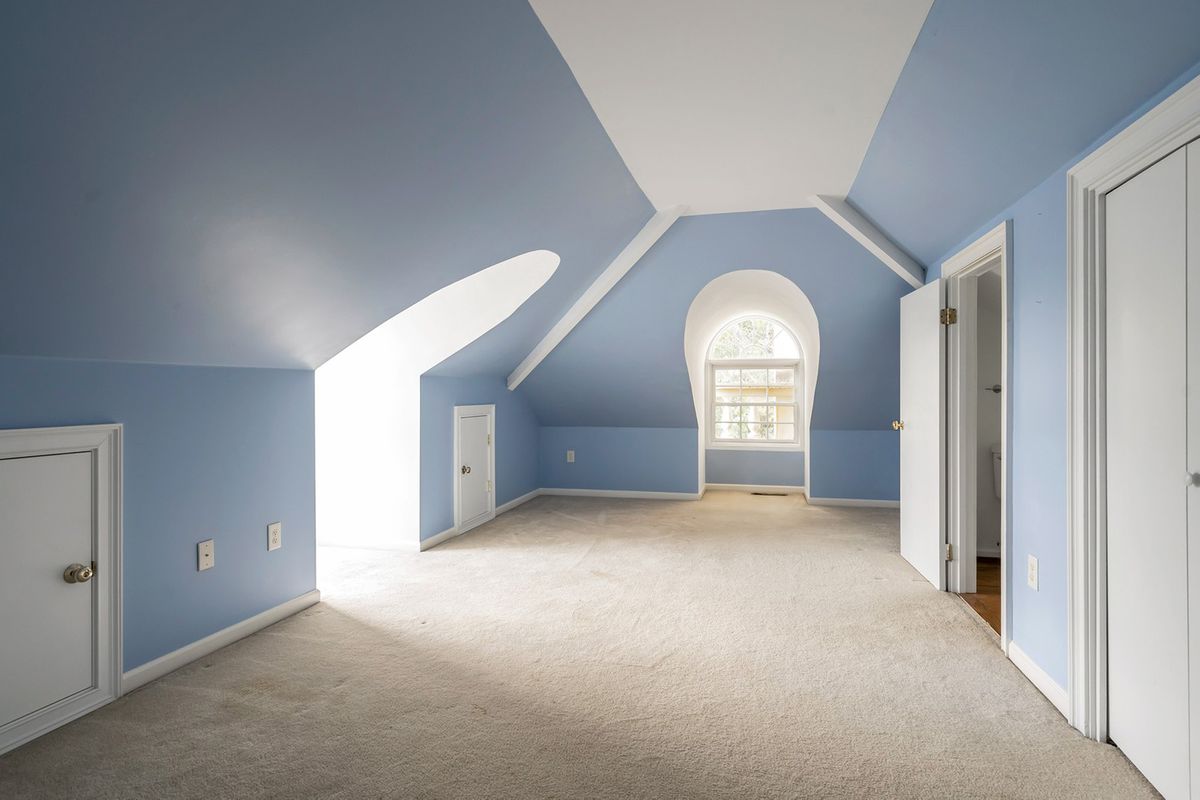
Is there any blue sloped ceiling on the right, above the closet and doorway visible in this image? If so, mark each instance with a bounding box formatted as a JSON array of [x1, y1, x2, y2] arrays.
[[850, 0, 1200, 265]]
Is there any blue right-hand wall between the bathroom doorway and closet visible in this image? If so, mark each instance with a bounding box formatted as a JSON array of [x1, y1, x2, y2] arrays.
[[929, 57, 1200, 686]]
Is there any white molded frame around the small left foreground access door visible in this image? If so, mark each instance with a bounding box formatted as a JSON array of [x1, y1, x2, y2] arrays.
[[0, 425, 122, 753]]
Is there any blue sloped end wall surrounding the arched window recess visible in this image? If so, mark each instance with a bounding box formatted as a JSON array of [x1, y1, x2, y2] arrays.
[[517, 209, 912, 431]]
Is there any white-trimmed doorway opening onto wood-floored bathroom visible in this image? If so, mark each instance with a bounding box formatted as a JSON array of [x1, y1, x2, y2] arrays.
[[942, 223, 1009, 646]]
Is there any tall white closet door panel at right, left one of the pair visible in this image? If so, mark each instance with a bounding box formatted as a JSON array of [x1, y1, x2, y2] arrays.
[[1105, 150, 1200, 798]]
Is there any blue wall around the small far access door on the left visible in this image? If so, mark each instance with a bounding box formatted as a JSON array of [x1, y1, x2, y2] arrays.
[[421, 375, 540, 539]]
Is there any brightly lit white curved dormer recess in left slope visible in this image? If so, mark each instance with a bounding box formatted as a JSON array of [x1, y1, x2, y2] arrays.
[[316, 249, 559, 548]]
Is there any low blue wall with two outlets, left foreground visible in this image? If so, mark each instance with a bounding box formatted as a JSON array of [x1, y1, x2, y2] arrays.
[[0, 356, 316, 669]]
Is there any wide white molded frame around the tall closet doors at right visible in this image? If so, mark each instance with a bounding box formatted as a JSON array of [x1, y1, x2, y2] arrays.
[[1067, 71, 1200, 741]]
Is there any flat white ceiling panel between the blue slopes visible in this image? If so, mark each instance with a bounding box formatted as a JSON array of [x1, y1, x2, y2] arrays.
[[530, 0, 931, 213]]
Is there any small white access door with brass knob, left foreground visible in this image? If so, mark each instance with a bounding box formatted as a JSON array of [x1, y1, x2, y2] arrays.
[[0, 452, 96, 729]]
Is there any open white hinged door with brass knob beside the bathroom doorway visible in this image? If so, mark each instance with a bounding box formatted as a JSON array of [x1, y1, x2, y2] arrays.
[[900, 278, 946, 589]]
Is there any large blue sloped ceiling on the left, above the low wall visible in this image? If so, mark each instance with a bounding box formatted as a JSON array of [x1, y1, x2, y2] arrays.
[[0, 0, 653, 368]]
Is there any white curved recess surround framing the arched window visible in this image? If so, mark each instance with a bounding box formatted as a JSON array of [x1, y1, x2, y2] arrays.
[[684, 270, 821, 487]]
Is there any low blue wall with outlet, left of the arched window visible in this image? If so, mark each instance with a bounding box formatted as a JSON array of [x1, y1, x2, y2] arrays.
[[538, 427, 698, 493]]
